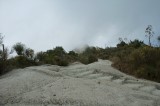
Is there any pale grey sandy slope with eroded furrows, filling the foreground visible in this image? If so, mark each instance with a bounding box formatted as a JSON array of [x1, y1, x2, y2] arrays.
[[0, 60, 160, 106]]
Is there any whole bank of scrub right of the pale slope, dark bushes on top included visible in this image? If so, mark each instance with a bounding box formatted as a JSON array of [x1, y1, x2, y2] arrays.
[[95, 39, 160, 82]]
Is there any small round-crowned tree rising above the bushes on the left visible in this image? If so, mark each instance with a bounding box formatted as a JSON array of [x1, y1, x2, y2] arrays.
[[13, 42, 25, 55]]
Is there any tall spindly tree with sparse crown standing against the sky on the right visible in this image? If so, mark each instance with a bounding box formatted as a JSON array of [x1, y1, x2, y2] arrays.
[[145, 25, 154, 46]]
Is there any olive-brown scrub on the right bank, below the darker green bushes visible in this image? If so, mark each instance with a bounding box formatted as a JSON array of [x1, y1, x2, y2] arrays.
[[112, 46, 160, 82]]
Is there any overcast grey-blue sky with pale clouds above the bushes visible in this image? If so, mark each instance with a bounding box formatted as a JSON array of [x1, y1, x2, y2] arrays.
[[0, 0, 160, 51]]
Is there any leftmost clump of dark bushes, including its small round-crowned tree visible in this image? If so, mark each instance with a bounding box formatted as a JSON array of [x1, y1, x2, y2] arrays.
[[0, 39, 37, 74]]
